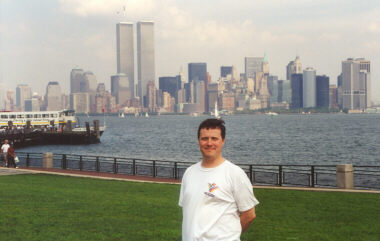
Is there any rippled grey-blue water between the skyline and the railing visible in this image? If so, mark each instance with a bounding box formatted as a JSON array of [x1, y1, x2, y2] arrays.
[[20, 114, 380, 165]]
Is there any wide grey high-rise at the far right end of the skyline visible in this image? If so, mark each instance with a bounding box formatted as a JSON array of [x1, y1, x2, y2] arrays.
[[342, 58, 371, 110]]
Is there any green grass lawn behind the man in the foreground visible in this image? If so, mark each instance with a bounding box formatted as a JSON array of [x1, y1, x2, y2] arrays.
[[0, 175, 380, 241]]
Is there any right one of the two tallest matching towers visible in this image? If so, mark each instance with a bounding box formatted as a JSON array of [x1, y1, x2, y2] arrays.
[[137, 22, 156, 107]]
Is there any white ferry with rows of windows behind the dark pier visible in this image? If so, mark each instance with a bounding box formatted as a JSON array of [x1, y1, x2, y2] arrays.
[[0, 110, 78, 128]]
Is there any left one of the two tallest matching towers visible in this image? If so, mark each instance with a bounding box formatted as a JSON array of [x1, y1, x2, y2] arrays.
[[116, 23, 135, 98]]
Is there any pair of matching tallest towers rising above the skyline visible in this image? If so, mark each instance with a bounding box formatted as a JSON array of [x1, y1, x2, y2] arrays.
[[116, 21, 155, 105]]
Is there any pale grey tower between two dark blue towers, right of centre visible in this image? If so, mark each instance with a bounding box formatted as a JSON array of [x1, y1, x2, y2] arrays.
[[302, 67, 317, 108]]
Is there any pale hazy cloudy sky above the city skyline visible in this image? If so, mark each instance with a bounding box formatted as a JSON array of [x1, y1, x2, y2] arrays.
[[0, 0, 380, 100]]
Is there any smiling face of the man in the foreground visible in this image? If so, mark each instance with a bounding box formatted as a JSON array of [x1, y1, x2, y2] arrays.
[[198, 128, 224, 160]]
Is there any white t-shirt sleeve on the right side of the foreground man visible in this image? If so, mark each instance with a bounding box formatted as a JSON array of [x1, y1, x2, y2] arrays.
[[233, 167, 259, 212]]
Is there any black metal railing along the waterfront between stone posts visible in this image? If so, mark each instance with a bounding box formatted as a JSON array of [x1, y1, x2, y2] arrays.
[[13, 152, 380, 189]]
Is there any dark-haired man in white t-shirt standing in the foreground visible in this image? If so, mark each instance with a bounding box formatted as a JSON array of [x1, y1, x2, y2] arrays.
[[179, 119, 259, 241]]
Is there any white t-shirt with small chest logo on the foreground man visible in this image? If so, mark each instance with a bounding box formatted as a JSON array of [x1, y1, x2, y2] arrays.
[[179, 160, 259, 241]]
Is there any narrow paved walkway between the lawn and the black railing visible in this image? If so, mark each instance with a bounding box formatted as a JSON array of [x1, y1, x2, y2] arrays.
[[0, 167, 380, 194]]
